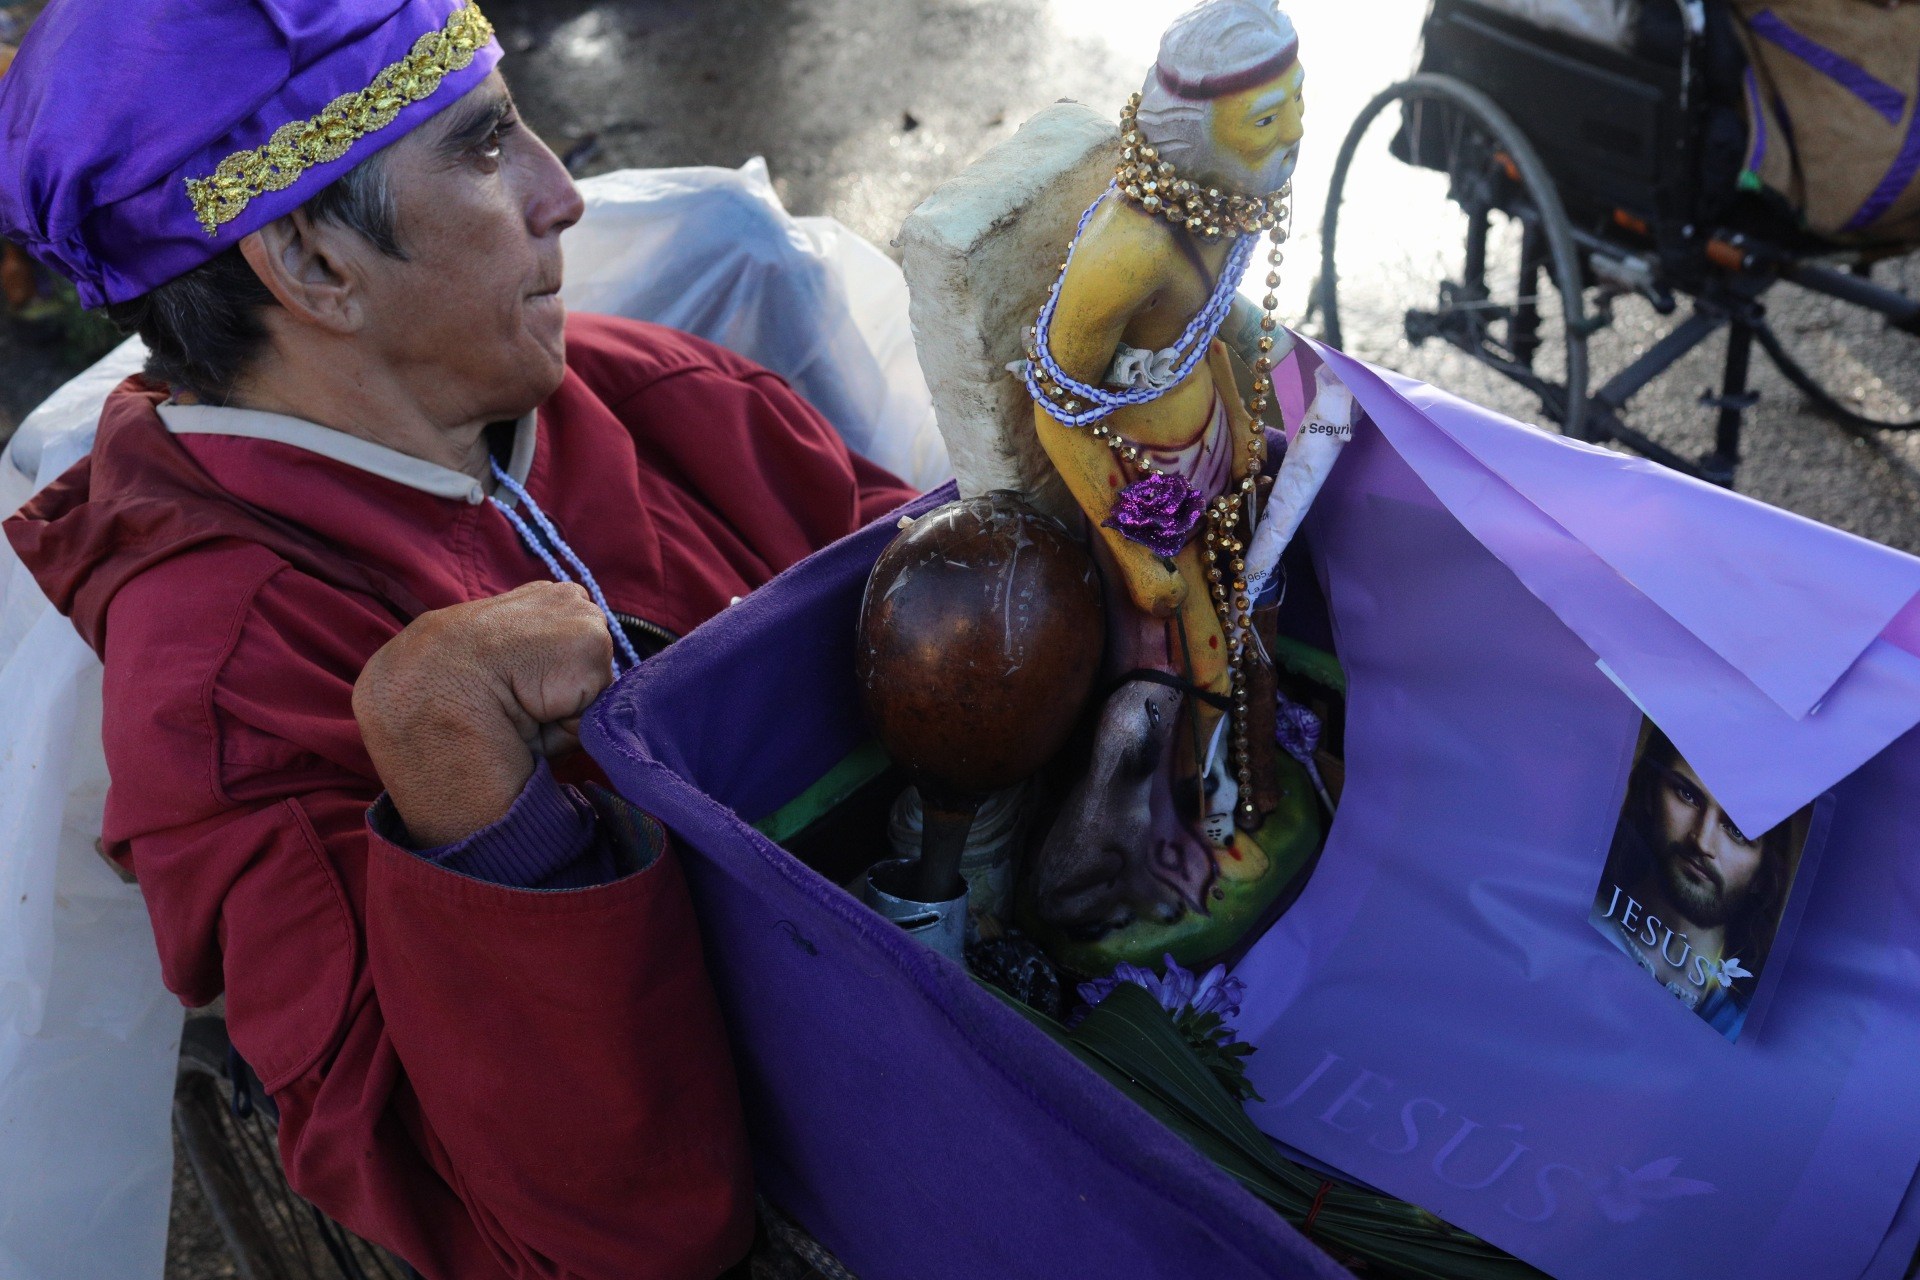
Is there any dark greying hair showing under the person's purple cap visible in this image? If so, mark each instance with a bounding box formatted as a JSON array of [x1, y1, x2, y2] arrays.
[[106, 152, 407, 405]]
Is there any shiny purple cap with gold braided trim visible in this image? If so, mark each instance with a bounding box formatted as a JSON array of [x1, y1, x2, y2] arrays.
[[0, 0, 501, 307]]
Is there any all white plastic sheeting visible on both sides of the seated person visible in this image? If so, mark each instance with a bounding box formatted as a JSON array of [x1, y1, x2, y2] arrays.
[[0, 159, 950, 1280]]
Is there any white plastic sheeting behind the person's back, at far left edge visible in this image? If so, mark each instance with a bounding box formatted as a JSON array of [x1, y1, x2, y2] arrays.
[[0, 342, 180, 1280]]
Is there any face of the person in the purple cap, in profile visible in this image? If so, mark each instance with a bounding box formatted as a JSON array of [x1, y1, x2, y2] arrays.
[[349, 71, 584, 422]]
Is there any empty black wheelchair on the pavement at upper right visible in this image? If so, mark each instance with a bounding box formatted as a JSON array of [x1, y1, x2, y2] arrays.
[[1313, 0, 1920, 486]]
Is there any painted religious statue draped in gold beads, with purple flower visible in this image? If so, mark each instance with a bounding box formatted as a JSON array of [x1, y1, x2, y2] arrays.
[[1021, 0, 1352, 967]]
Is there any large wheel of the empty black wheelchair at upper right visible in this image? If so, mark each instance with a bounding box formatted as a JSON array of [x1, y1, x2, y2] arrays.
[[1319, 75, 1590, 439]]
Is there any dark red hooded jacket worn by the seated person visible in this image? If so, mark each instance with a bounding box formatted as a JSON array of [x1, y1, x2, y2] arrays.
[[6, 317, 912, 1280]]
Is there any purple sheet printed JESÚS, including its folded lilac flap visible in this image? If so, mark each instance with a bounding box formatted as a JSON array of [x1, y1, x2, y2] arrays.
[[1236, 353, 1920, 1280]]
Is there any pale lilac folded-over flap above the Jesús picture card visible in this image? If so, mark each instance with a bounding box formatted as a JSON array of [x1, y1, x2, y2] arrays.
[[1302, 343, 1920, 831]]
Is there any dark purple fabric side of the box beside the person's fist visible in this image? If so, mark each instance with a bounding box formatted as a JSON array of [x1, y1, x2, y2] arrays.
[[584, 491, 1346, 1280]]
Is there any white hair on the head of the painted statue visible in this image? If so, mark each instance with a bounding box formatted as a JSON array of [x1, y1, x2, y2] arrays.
[[1139, 0, 1298, 167]]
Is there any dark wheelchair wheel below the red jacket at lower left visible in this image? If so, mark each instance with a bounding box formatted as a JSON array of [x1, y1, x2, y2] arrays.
[[173, 1017, 415, 1280]]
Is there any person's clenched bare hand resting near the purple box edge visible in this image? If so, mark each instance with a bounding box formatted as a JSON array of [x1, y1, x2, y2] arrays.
[[353, 581, 612, 848]]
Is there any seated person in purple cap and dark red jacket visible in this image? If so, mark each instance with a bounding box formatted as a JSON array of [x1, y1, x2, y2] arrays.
[[0, 0, 910, 1280]]
